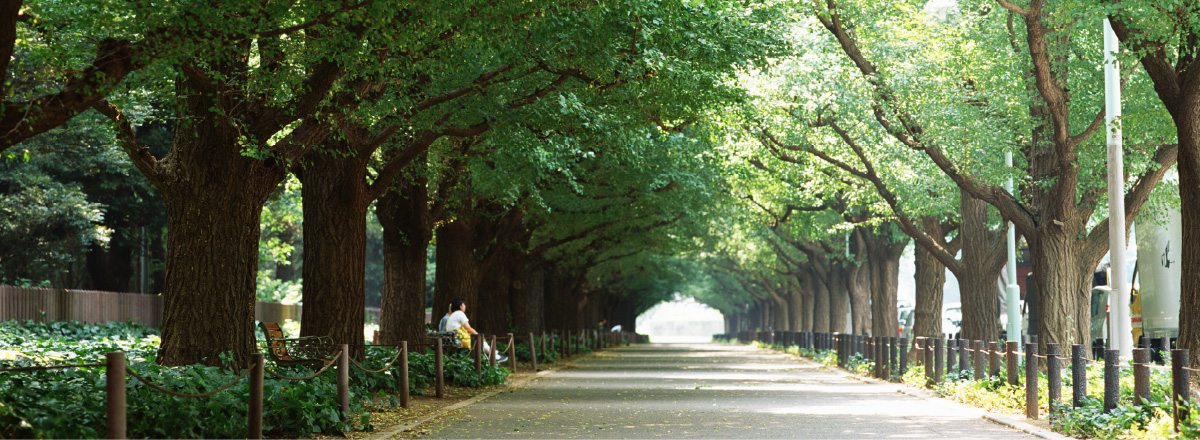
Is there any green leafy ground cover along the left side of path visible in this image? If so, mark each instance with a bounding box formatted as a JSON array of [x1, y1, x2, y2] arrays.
[[0, 321, 510, 439]]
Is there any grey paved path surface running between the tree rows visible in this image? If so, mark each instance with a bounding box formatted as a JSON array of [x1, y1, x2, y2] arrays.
[[417, 344, 1046, 439]]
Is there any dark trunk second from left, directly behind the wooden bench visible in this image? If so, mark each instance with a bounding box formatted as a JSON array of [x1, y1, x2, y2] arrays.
[[296, 148, 371, 357]]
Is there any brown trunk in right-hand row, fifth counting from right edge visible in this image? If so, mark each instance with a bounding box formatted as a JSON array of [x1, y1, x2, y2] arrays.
[[864, 234, 905, 336]]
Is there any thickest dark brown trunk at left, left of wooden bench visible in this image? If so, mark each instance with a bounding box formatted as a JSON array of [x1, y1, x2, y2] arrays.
[[155, 137, 284, 367]]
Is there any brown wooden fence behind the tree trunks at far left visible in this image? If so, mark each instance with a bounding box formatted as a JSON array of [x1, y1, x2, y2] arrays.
[[0, 285, 309, 327]]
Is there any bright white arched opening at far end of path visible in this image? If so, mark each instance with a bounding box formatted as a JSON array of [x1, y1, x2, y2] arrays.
[[637, 296, 725, 343]]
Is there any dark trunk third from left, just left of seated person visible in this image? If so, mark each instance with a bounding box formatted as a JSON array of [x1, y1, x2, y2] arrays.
[[376, 177, 434, 345]]
